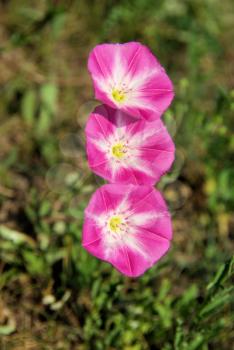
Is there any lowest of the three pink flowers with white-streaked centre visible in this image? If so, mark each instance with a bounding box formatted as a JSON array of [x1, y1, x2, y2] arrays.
[[82, 184, 172, 277]]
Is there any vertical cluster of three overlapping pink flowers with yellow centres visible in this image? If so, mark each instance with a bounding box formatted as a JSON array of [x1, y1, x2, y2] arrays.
[[82, 42, 175, 277]]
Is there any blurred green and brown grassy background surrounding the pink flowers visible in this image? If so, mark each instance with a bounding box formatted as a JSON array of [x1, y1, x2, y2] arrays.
[[0, 0, 234, 350]]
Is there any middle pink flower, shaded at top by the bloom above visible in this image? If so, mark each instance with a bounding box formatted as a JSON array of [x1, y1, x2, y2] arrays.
[[86, 105, 175, 185]]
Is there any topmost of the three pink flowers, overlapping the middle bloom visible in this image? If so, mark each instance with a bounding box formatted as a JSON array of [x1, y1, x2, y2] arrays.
[[88, 42, 174, 121]]
